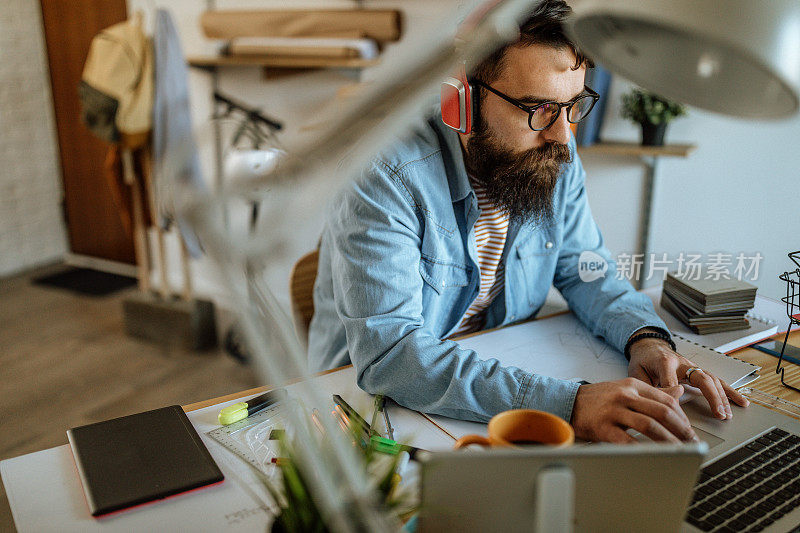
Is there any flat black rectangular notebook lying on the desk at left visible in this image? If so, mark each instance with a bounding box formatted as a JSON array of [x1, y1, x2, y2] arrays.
[[67, 405, 225, 516]]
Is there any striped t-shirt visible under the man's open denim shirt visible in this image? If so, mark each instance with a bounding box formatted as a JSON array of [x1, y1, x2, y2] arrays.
[[454, 179, 508, 335]]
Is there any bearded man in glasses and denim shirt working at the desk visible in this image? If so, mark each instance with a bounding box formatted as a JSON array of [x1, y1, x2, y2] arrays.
[[309, 0, 747, 442]]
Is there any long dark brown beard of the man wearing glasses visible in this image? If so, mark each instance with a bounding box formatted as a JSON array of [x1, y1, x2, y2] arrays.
[[464, 122, 572, 223]]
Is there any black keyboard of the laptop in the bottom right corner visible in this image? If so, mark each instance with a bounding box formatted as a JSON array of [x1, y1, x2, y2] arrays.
[[686, 429, 800, 532]]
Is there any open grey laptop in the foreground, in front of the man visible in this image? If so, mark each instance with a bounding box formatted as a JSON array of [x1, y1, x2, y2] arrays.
[[420, 396, 800, 532]]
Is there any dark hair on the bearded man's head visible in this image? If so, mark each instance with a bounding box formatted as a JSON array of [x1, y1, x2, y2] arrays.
[[472, 0, 594, 85]]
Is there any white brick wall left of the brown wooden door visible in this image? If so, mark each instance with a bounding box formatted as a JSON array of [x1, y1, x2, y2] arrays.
[[0, 0, 67, 276]]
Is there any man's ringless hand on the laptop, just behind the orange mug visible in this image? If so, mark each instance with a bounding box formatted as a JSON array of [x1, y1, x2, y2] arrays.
[[571, 378, 697, 443]]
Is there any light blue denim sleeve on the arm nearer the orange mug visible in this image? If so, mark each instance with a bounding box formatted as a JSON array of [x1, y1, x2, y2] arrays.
[[326, 162, 578, 421]]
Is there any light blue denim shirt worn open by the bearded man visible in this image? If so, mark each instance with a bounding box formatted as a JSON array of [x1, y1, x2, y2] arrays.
[[309, 117, 667, 421]]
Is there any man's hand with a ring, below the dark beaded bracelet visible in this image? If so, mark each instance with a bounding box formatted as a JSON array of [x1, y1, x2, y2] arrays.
[[628, 331, 750, 420]]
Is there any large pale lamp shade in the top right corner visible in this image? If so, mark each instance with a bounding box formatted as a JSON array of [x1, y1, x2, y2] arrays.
[[568, 0, 800, 118]]
